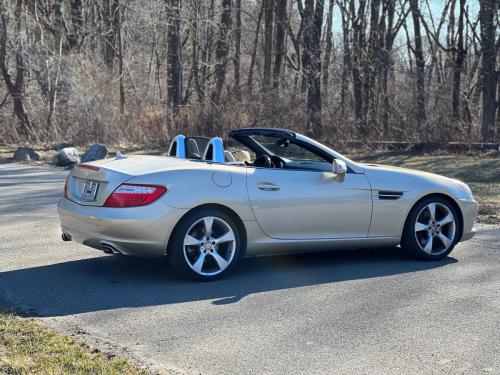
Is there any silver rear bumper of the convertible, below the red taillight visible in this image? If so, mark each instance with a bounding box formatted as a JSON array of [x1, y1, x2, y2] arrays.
[[57, 198, 187, 257]]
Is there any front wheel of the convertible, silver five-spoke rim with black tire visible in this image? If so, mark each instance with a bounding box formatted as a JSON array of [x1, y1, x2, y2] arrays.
[[401, 197, 460, 260]]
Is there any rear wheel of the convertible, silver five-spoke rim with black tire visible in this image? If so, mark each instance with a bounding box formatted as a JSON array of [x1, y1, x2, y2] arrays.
[[167, 209, 241, 281]]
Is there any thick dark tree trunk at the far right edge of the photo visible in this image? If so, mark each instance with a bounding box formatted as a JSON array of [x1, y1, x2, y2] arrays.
[[479, 0, 497, 142]]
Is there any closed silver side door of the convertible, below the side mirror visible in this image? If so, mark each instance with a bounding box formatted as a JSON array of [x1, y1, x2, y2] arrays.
[[247, 167, 372, 239]]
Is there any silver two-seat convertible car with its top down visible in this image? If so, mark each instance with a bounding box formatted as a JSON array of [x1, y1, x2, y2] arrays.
[[58, 128, 478, 280]]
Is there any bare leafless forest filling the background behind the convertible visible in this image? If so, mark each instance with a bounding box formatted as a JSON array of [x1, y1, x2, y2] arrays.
[[0, 0, 500, 145]]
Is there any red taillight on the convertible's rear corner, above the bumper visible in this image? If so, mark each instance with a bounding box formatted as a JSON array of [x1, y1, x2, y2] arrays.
[[104, 184, 167, 207]]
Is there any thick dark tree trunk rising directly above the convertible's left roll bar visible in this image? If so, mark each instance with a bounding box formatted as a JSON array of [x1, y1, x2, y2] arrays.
[[167, 0, 182, 112]]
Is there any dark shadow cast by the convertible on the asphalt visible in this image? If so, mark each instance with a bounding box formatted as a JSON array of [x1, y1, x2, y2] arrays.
[[0, 248, 457, 316]]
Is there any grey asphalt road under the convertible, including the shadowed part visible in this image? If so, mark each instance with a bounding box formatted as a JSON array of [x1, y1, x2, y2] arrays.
[[0, 164, 500, 374]]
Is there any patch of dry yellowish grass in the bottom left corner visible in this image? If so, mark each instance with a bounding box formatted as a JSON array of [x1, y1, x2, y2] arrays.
[[0, 310, 146, 375]]
